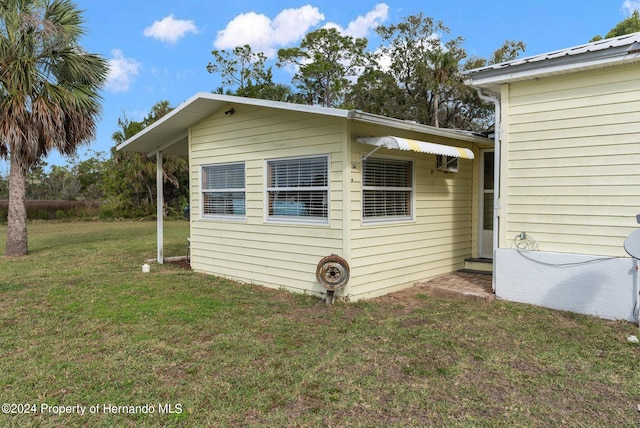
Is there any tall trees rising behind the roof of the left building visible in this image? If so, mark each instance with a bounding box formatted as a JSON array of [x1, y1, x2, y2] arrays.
[[207, 13, 525, 131]]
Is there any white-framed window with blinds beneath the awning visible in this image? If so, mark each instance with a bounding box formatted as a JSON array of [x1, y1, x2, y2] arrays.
[[362, 157, 414, 221]]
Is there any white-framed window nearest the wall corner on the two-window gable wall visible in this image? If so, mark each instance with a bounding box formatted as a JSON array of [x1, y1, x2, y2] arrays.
[[267, 155, 329, 223]]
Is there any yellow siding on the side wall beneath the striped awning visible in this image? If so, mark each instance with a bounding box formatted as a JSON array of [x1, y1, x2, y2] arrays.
[[345, 125, 475, 299]]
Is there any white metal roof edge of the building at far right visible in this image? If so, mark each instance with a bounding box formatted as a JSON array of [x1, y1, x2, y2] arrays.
[[463, 33, 640, 93]]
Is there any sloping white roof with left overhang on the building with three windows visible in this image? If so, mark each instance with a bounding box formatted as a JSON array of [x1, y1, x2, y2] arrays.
[[117, 92, 490, 155]]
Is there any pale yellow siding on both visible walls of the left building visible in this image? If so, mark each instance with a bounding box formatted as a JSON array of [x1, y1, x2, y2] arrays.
[[190, 105, 477, 300]]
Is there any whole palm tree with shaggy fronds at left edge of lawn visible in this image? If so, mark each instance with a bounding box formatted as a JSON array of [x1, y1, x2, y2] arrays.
[[0, 0, 108, 256]]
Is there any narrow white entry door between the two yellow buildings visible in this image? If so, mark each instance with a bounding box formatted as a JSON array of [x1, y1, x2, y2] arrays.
[[478, 150, 494, 259]]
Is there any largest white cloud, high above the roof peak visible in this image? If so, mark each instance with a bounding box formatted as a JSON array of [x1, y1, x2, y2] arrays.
[[214, 5, 324, 57]]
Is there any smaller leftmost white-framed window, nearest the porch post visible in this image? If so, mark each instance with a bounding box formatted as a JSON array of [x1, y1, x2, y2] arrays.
[[202, 162, 246, 218]]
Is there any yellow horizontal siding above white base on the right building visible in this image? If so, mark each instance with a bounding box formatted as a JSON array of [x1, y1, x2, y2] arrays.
[[500, 64, 640, 256]]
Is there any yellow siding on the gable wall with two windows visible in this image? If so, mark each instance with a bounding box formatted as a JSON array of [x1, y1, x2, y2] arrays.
[[190, 105, 346, 292]]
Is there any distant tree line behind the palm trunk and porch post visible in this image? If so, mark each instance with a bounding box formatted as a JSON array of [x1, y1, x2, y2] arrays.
[[0, 101, 188, 220]]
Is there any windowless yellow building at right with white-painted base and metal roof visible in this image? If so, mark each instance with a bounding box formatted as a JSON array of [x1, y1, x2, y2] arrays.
[[466, 33, 640, 321]]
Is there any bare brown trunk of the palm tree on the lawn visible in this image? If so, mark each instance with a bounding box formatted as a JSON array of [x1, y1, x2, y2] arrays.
[[5, 156, 29, 257]]
